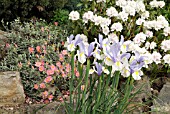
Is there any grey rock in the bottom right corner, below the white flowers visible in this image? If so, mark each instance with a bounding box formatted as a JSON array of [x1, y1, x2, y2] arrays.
[[152, 82, 170, 114]]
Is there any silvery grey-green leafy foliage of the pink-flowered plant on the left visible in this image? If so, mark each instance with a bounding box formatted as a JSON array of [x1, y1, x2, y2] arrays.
[[0, 20, 67, 97]]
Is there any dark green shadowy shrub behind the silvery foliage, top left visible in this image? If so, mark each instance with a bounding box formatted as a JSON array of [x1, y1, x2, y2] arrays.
[[0, 0, 68, 25]]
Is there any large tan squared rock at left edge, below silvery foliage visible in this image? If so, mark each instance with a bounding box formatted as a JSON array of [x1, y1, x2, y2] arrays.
[[0, 71, 25, 106]]
